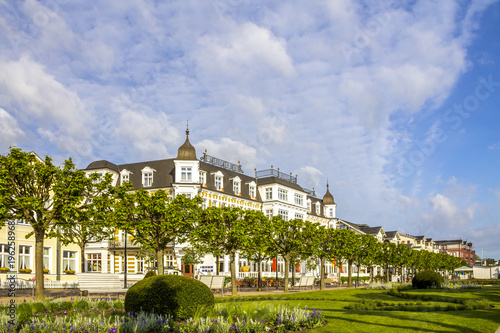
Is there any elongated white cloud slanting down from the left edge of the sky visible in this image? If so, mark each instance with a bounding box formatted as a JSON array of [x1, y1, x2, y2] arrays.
[[0, 56, 91, 153]]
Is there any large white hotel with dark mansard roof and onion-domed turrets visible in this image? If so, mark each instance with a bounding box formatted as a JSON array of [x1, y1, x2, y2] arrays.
[[85, 131, 338, 281]]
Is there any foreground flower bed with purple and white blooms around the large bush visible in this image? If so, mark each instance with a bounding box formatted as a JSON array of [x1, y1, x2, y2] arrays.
[[0, 300, 325, 333]]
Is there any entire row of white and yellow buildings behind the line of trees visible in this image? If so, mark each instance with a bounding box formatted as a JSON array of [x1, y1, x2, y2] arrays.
[[0, 130, 475, 281]]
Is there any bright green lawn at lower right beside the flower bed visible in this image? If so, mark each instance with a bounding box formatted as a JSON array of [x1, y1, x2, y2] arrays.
[[229, 286, 500, 333]]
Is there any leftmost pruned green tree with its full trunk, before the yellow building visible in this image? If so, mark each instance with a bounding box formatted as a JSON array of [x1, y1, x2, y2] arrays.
[[0, 147, 86, 301]]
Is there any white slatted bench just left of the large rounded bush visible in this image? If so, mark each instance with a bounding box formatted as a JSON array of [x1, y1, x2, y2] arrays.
[[76, 273, 127, 297]]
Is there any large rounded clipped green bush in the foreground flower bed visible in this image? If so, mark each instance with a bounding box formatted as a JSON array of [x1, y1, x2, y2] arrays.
[[125, 275, 215, 319]]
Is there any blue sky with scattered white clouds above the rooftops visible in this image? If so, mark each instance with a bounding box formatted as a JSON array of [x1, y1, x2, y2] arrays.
[[0, 0, 500, 260]]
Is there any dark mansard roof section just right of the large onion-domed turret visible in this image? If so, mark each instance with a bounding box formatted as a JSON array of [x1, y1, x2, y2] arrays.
[[200, 161, 261, 201]]
